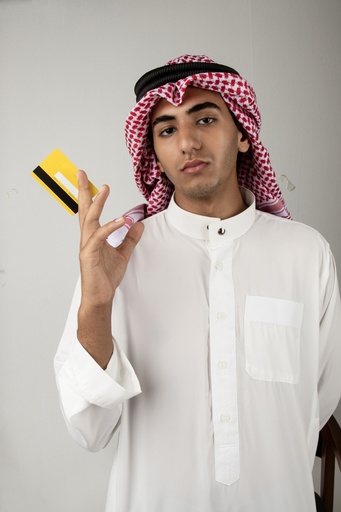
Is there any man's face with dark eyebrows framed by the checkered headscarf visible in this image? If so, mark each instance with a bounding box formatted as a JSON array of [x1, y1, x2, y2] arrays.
[[151, 87, 249, 211]]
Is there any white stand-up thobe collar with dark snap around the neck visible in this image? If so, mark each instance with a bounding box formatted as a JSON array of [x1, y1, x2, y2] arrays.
[[166, 187, 256, 245]]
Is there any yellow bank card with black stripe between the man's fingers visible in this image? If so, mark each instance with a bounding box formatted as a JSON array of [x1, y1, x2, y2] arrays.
[[31, 149, 98, 215]]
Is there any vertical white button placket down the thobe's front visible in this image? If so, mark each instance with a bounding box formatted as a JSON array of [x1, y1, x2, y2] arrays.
[[210, 243, 239, 484]]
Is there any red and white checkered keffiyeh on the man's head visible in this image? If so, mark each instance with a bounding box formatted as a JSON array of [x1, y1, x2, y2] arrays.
[[109, 55, 290, 246]]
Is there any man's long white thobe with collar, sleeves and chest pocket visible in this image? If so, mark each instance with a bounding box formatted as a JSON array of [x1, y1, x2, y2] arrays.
[[55, 191, 341, 512]]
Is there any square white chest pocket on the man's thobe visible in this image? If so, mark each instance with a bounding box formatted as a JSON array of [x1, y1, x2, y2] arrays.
[[244, 296, 303, 384]]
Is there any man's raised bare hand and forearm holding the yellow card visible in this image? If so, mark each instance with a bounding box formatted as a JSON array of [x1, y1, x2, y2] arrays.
[[78, 171, 143, 368]]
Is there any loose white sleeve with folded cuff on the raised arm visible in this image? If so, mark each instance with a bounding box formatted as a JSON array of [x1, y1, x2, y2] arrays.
[[54, 282, 141, 451]]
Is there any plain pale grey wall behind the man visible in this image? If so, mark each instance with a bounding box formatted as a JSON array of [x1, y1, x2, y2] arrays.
[[0, 0, 341, 512]]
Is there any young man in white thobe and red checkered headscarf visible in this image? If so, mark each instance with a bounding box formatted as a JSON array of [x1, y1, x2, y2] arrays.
[[55, 56, 341, 512]]
